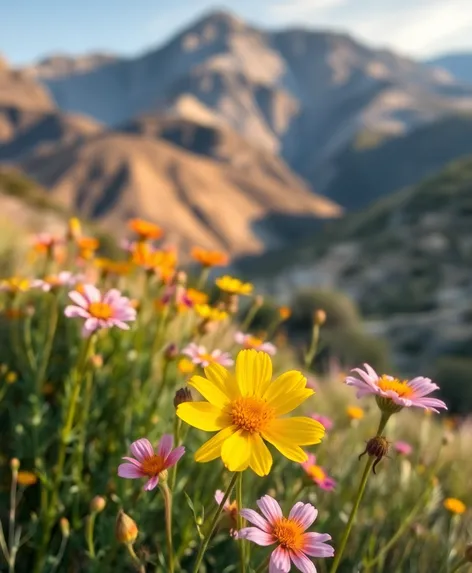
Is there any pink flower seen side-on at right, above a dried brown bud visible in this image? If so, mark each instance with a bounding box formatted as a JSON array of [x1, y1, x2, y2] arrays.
[[346, 364, 447, 413]]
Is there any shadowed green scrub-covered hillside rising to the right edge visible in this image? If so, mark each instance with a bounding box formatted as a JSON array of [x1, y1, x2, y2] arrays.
[[238, 156, 472, 373]]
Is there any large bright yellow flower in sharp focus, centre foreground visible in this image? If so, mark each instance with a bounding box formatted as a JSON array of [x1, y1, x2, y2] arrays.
[[177, 350, 325, 476]]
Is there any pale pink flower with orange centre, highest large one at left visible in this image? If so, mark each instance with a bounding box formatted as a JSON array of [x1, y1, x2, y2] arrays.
[[64, 284, 136, 336]]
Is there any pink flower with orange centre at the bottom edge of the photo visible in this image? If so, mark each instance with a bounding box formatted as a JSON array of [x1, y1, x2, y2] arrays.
[[238, 495, 334, 573]]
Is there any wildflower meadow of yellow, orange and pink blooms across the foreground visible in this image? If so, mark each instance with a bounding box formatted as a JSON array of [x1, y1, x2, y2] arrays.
[[0, 219, 472, 573]]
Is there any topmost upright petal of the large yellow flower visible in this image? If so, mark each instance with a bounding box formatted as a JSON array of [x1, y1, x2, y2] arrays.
[[236, 349, 272, 396]]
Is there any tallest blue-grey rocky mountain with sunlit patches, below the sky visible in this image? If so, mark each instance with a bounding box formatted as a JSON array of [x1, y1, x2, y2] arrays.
[[28, 11, 472, 206]]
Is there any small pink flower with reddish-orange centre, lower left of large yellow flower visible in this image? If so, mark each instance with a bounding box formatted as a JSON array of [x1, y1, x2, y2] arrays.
[[118, 434, 185, 491]]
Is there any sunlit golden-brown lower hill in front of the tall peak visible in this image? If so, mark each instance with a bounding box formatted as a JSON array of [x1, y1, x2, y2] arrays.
[[21, 132, 341, 254]]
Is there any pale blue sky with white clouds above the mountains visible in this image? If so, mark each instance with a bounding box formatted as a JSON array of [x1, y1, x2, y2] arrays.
[[0, 0, 472, 65]]
